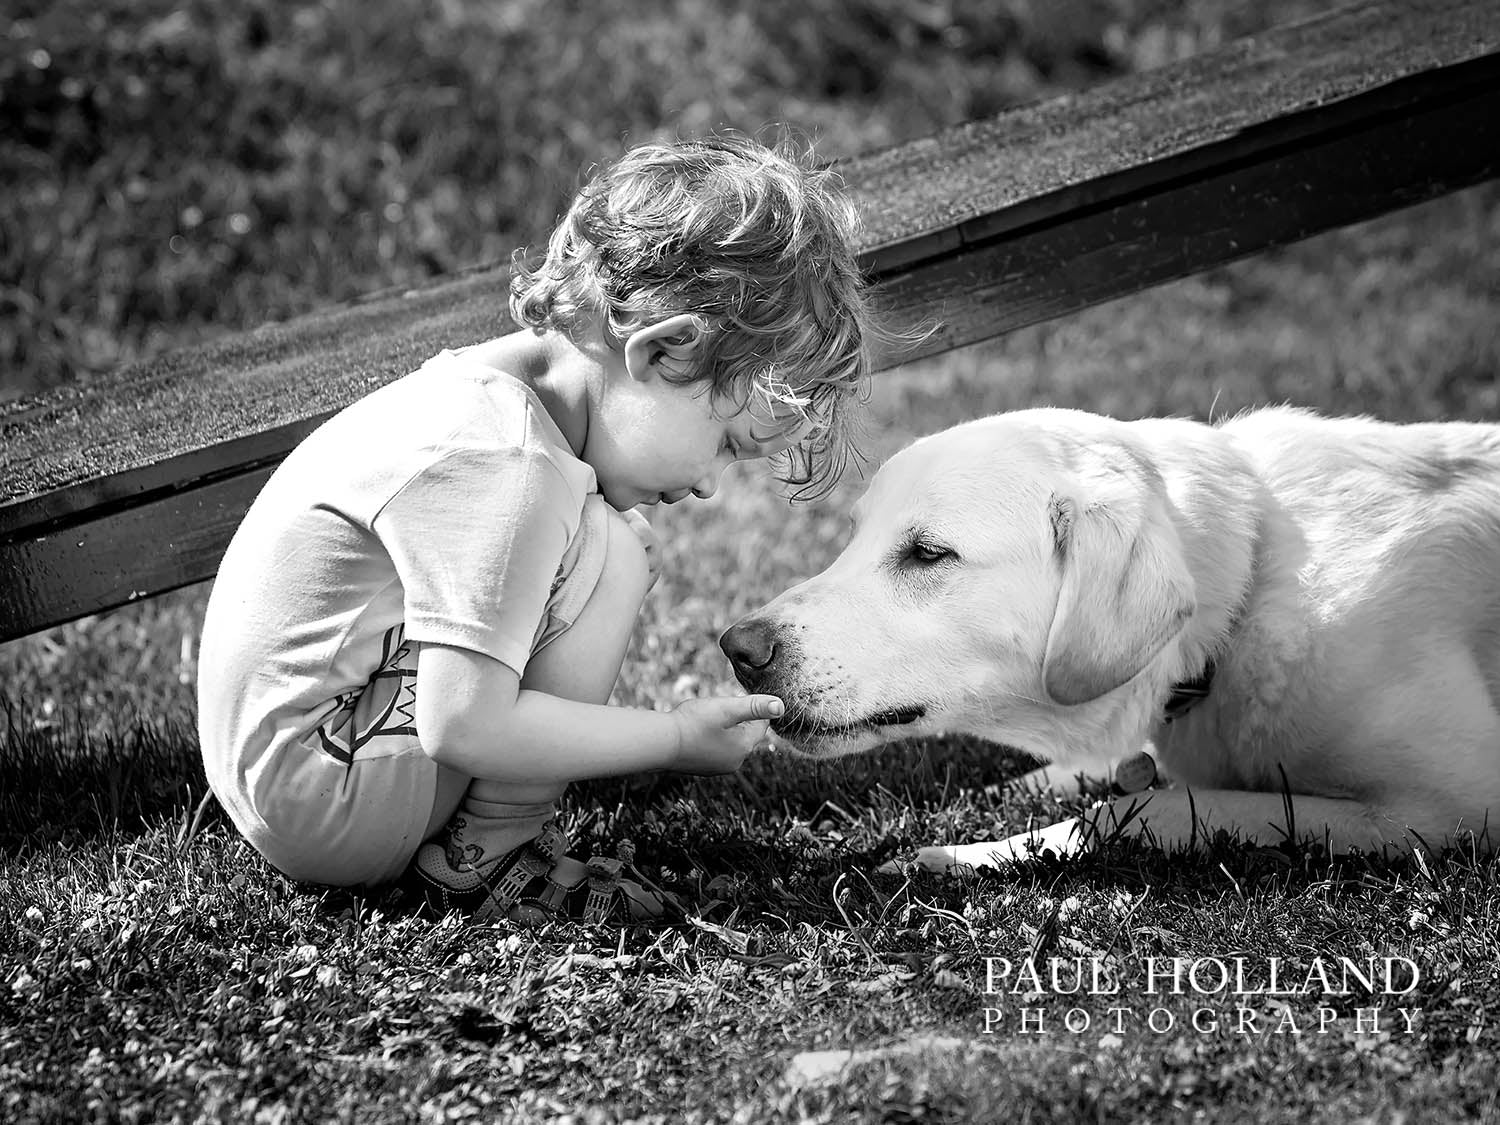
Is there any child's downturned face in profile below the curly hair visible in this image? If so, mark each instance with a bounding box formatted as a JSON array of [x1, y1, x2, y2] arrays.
[[584, 378, 803, 512]]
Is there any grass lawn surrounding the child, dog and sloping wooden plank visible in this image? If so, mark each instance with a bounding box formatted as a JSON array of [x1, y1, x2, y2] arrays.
[[0, 0, 1500, 1122]]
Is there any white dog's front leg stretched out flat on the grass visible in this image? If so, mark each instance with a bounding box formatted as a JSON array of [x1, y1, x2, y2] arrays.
[[893, 789, 1452, 872]]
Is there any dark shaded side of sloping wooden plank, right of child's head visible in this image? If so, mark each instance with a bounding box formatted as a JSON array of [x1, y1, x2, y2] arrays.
[[881, 59, 1500, 361]]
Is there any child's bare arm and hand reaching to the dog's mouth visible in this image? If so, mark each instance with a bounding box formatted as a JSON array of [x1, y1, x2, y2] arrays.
[[417, 645, 782, 782]]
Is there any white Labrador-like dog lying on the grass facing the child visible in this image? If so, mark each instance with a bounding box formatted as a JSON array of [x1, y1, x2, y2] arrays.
[[720, 410, 1500, 870]]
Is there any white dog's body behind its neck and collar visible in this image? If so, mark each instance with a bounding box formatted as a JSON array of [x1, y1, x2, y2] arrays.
[[1160, 410, 1500, 828]]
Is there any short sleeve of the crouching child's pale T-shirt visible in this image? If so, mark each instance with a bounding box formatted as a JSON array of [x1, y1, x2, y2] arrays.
[[374, 449, 579, 675]]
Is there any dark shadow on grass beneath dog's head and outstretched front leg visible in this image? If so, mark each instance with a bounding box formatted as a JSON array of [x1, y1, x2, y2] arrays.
[[572, 737, 1497, 921]]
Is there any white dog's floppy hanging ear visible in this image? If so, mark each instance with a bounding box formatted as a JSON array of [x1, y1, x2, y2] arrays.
[[1043, 479, 1194, 707]]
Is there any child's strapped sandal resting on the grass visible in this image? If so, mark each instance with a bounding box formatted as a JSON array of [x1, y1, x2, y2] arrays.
[[410, 822, 665, 924]]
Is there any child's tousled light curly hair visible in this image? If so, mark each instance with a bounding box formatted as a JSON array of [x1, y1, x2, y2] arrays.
[[510, 134, 885, 498]]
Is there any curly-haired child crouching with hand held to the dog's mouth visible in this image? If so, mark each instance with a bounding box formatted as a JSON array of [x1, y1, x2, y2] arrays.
[[198, 135, 875, 920]]
